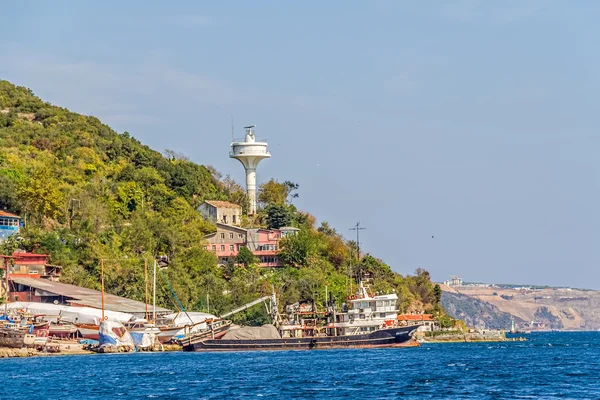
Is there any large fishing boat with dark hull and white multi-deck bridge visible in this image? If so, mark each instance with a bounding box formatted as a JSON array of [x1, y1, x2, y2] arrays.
[[182, 281, 420, 351]]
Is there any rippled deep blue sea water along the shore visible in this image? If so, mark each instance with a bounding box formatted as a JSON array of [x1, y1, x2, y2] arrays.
[[0, 332, 600, 400]]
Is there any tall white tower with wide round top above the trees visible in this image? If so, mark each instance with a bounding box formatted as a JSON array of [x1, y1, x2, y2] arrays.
[[229, 125, 271, 215]]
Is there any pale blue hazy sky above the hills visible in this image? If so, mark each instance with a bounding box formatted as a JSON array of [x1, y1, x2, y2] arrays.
[[0, 0, 600, 289]]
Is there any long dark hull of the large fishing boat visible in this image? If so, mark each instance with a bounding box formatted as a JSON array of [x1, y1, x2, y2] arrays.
[[183, 325, 419, 351]]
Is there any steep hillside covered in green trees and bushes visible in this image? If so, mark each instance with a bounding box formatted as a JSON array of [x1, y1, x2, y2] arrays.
[[0, 81, 437, 322]]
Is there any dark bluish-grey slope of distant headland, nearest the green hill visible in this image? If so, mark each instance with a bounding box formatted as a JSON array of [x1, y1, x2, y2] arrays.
[[442, 291, 522, 329]]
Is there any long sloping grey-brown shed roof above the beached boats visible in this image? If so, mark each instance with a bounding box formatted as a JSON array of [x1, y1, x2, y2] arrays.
[[11, 278, 170, 313]]
